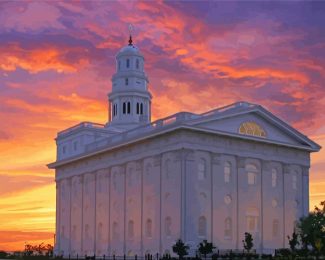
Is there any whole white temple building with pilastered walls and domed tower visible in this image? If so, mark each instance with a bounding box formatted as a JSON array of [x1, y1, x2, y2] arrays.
[[48, 34, 320, 256]]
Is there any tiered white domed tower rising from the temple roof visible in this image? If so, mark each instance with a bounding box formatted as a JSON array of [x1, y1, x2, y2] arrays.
[[108, 34, 152, 130]]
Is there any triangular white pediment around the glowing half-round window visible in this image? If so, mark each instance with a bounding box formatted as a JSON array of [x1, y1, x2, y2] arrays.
[[192, 109, 320, 150]]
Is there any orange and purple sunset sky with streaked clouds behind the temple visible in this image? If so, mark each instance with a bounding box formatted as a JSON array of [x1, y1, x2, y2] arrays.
[[0, 1, 325, 250]]
